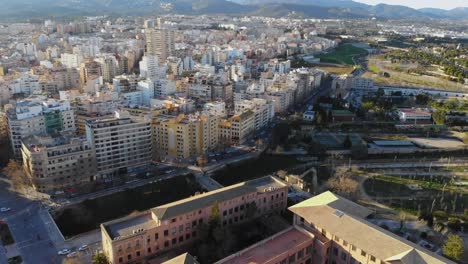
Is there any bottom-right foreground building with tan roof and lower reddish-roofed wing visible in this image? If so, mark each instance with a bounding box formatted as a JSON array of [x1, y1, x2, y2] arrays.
[[216, 192, 454, 264]]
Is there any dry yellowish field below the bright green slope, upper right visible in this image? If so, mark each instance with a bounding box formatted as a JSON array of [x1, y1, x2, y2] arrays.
[[363, 56, 468, 92]]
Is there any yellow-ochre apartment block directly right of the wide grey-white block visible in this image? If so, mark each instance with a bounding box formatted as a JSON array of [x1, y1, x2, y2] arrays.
[[152, 114, 220, 159]]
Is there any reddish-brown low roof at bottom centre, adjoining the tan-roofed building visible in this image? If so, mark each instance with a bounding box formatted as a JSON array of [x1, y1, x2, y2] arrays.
[[217, 227, 313, 264]]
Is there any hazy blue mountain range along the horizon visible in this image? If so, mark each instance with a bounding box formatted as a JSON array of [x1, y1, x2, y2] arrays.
[[0, 0, 468, 20]]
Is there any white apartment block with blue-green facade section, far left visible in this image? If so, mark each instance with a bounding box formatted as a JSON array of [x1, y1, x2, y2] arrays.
[[6, 96, 75, 159]]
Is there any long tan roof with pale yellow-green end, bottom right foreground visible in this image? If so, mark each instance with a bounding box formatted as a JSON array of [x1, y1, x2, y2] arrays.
[[289, 192, 453, 264]]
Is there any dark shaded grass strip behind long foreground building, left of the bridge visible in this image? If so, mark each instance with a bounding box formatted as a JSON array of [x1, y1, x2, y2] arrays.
[[52, 175, 201, 237]]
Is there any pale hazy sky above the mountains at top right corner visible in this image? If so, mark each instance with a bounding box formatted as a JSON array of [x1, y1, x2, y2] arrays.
[[355, 0, 468, 9]]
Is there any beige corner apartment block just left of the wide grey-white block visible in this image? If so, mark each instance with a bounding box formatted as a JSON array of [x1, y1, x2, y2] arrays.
[[21, 133, 97, 193]]
